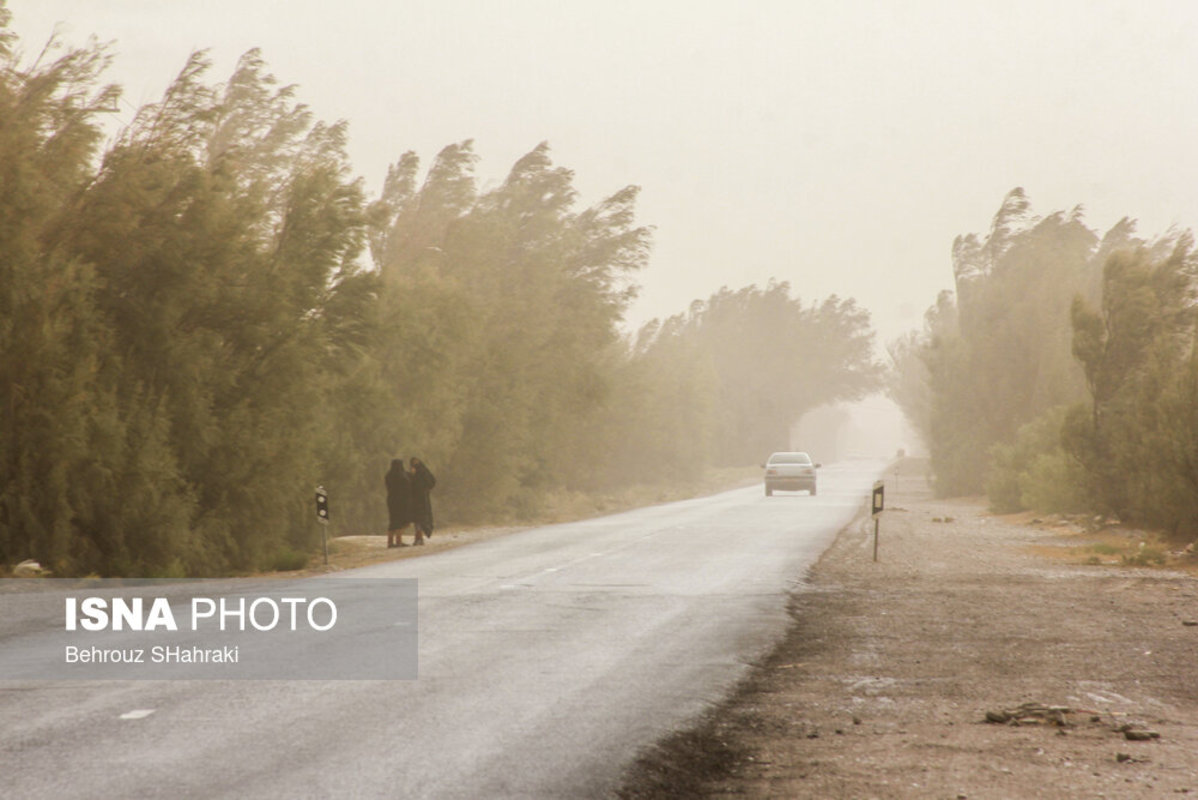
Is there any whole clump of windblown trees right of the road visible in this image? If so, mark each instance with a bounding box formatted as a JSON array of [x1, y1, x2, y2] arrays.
[[890, 190, 1198, 537]]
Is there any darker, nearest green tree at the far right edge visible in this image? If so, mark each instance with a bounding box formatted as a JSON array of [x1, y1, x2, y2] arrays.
[[1065, 240, 1198, 535]]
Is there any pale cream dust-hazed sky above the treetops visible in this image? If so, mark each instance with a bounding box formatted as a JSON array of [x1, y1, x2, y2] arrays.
[[8, 0, 1198, 340]]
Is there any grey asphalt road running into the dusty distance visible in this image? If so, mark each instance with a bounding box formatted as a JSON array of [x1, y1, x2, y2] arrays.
[[0, 461, 883, 800]]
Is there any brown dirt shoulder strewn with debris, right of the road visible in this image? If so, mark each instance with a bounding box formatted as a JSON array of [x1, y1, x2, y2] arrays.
[[619, 459, 1198, 800]]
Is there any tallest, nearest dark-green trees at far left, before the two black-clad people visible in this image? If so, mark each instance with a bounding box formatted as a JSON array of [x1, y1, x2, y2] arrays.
[[0, 25, 365, 575]]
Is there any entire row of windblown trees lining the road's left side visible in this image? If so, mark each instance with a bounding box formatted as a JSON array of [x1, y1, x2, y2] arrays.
[[0, 17, 879, 567]]
